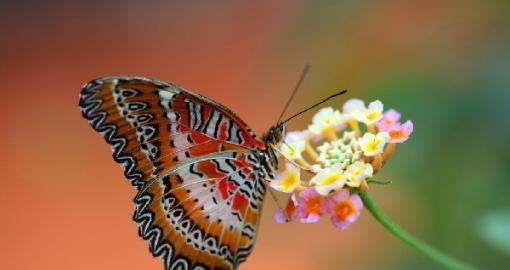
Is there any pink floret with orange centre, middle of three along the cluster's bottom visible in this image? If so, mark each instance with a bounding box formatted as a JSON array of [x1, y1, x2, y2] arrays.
[[297, 187, 327, 223]]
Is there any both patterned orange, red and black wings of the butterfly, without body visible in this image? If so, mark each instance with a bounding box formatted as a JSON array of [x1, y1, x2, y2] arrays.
[[80, 77, 265, 269]]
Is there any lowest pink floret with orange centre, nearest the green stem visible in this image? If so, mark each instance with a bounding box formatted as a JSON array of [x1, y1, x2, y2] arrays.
[[327, 189, 363, 230]]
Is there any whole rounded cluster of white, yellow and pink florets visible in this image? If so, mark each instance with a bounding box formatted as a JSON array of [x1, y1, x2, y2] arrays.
[[269, 99, 413, 230]]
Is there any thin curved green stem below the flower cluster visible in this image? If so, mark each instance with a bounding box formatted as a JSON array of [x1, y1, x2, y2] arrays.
[[357, 190, 475, 270]]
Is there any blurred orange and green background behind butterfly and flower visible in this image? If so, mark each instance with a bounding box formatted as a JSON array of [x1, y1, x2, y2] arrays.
[[0, 0, 510, 270]]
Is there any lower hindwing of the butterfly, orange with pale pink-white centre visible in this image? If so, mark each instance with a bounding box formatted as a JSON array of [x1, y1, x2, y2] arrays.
[[134, 151, 265, 269]]
